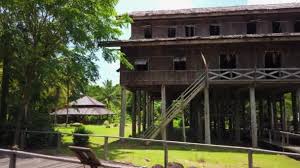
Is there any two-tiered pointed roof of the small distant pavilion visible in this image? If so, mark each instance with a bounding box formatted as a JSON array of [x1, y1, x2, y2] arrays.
[[50, 96, 114, 116]]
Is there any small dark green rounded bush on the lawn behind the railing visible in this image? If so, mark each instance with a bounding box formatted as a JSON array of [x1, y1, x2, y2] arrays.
[[73, 126, 92, 146]]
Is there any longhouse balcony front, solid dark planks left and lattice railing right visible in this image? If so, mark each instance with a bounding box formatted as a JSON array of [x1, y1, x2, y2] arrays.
[[121, 68, 300, 86]]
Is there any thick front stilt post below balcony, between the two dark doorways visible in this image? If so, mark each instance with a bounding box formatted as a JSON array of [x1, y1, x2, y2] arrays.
[[250, 87, 257, 147]]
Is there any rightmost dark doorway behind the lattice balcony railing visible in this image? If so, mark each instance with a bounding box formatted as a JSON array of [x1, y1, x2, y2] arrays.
[[265, 51, 281, 79]]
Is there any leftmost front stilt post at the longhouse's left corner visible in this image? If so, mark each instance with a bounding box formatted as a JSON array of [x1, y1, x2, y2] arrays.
[[119, 87, 126, 137]]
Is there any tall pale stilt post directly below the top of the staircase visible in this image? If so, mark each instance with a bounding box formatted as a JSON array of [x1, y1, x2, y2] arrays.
[[204, 86, 211, 144]]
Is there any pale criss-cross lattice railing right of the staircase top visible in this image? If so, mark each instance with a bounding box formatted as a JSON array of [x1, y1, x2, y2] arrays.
[[208, 68, 300, 81]]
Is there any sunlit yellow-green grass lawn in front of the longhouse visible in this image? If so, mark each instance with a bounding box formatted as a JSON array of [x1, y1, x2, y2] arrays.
[[56, 125, 300, 168]]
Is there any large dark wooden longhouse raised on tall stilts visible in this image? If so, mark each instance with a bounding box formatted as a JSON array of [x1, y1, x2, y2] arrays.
[[105, 3, 300, 147]]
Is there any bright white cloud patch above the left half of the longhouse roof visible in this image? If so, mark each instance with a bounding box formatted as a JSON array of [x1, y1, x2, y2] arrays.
[[156, 0, 193, 9]]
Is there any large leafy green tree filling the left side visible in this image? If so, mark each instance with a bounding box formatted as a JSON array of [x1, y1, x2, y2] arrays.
[[0, 0, 130, 146]]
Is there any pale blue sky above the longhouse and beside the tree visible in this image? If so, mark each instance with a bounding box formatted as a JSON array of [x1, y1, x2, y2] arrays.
[[97, 0, 300, 84]]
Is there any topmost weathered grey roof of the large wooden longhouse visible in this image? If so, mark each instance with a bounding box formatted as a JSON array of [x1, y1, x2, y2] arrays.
[[129, 3, 300, 20]]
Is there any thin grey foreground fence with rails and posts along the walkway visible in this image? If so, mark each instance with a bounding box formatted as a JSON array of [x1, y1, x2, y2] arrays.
[[0, 131, 300, 168]]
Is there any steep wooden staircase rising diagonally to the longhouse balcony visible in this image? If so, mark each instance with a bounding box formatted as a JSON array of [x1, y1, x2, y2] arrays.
[[142, 70, 207, 139]]
